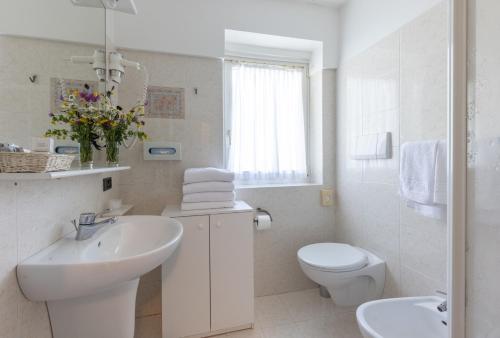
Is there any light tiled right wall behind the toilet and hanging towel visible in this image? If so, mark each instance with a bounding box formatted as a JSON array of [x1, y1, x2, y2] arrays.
[[336, 2, 447, 296]]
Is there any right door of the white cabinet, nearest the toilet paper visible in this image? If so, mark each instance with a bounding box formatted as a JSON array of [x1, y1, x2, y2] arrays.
[[210, 212, 254, 331]]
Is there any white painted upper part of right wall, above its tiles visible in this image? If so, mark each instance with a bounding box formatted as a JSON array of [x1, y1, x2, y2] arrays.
[[339, 0, 441, 63]]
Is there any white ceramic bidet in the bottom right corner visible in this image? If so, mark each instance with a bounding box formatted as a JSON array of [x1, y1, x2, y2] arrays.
[[356, 296, 448, 338]]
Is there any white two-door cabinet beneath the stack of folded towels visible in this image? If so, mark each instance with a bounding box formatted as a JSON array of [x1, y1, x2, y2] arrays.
[[162, 202, 254, 338]]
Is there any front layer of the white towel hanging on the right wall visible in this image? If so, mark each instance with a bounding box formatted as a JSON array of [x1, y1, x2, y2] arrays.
[[399, 141, 438, 204]]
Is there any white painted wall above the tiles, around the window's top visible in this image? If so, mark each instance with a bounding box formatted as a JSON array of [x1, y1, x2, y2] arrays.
[[115, 0, 338, 68]]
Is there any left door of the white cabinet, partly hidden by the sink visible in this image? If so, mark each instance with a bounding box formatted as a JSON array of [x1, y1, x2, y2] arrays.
[[162, 216, 210, 338]]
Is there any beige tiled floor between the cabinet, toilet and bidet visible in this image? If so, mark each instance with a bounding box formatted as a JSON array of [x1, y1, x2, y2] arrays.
[[213, 289, 362, 338]]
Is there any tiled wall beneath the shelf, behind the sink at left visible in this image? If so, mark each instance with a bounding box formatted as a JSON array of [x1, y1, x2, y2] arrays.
[[0, 176, 118, 338]]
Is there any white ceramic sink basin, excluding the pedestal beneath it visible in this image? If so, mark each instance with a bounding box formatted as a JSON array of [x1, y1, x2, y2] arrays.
[[17, 216, 186, 301]]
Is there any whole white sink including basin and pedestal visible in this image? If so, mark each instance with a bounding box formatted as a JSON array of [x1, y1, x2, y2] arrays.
[[17, 216, 183, 338]]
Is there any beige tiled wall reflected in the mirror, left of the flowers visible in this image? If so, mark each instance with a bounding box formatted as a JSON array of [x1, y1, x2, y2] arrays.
[[0, 35, 102, 148]]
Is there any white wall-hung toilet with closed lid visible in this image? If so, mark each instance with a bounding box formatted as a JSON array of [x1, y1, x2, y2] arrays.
[[297, 243, 385, 306]]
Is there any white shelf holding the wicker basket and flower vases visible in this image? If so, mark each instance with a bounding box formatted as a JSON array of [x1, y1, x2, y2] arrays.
[[0, 166, 130, 181]]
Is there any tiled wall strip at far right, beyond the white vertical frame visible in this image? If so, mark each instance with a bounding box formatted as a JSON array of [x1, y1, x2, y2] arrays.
[[466, 0, 500, 338]]
